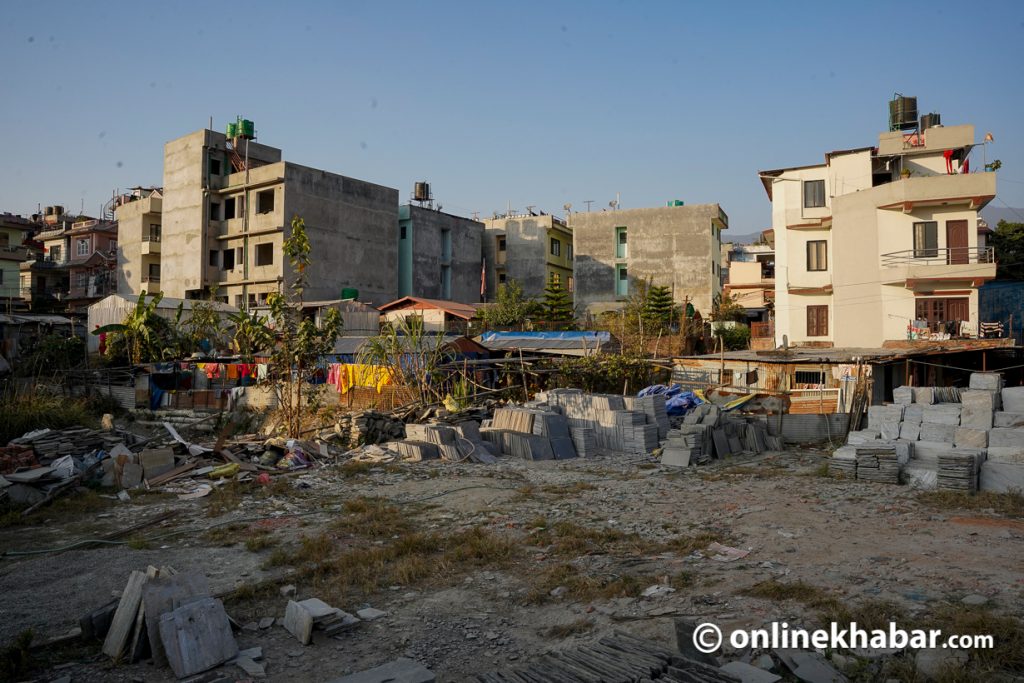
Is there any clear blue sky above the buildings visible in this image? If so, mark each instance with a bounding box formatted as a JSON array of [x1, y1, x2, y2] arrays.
[[0, 0, 1024, 233]]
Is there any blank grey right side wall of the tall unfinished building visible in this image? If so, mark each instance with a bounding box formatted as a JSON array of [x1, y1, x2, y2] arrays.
[[284, 163, 398, 305]]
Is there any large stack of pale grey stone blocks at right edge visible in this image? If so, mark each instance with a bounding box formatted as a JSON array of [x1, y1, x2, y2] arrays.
[[829, 373, 1024, 492]]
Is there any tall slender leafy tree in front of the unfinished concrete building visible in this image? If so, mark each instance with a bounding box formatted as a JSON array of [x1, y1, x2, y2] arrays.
[[267, 216, 341, 438]]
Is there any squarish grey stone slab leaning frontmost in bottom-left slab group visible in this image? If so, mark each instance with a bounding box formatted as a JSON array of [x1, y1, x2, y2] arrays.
[[160, 598, 239, 678]]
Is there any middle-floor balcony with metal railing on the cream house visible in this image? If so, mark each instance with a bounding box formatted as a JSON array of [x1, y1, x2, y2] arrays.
[[881, 247, 995, 288]]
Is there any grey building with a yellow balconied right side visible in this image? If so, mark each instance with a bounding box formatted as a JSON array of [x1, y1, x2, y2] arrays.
[[482, 212, 575, 301]]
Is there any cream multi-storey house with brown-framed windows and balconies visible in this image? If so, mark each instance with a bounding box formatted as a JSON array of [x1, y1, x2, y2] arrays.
[[760, 119, 995, 347]]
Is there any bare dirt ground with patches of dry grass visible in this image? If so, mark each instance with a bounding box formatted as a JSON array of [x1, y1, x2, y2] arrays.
[[0, 451, 1024, 681]]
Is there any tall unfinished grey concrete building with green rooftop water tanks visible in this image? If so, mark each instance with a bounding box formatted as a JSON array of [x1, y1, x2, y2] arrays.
[[122, 121, 398, 307]]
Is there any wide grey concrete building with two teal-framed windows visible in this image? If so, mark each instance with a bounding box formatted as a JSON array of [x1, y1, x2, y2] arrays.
[[569, 202, 729, 315]]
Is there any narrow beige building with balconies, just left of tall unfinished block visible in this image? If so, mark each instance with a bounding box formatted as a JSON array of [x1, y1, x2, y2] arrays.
[[116, 197, 163, 295]]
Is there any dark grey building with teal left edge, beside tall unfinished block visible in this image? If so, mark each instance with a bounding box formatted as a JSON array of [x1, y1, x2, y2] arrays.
[[395, 204, 483, 303]]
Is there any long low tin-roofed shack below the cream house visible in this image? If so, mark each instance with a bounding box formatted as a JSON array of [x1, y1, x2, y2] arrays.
[[672, 339, 1024, 413]]
